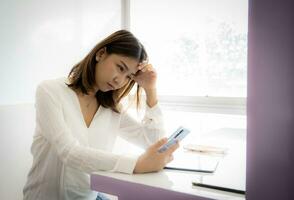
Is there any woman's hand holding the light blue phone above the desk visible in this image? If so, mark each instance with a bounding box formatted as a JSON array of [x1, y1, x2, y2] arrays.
[[134, 138, 179, 173]]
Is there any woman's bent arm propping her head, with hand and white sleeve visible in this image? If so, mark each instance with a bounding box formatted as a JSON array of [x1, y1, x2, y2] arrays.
[[120, 62, 165, 149]]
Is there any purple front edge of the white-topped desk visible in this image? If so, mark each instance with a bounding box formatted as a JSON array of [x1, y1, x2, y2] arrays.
[[91, 174, 209, 200]]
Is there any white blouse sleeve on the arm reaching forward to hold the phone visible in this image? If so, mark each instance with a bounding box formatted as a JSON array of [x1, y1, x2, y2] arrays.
[[35, 84, 137, 173]]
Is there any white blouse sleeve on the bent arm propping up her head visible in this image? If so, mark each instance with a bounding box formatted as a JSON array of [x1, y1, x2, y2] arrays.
[[120, 104, 165, 149]]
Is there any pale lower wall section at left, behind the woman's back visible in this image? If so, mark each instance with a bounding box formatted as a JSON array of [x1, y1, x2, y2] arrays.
[[0, 104, 35, 200]]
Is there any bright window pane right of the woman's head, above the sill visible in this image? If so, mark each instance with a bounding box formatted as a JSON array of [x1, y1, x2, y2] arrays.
[[130, 0, 247, 97]]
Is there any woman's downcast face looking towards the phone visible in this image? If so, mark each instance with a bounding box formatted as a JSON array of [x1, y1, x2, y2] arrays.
[[95, 53, 139, 92]]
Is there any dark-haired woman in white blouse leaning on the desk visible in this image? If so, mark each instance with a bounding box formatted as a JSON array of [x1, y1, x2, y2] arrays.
[[24, 30, 179, 200]]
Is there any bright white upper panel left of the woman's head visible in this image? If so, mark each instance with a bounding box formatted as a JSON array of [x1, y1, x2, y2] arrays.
[[0, 0, 121, 105]]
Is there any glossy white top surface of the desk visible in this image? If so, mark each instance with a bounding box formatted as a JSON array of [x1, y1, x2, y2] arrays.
[[92, 129, 246, 200]]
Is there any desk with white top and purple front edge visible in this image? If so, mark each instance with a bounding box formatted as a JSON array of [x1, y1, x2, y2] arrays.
[[91, 130, 246, 200]]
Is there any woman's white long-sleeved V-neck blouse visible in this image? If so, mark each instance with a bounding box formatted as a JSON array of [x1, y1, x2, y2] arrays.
[[23, 77, 164, 200]]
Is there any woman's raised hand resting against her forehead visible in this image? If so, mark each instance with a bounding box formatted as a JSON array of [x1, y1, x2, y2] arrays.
[[132, 62, 157, 91]]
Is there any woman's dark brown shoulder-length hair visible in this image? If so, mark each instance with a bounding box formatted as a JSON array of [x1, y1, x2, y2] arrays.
[[67, 30, 148, 113]]
